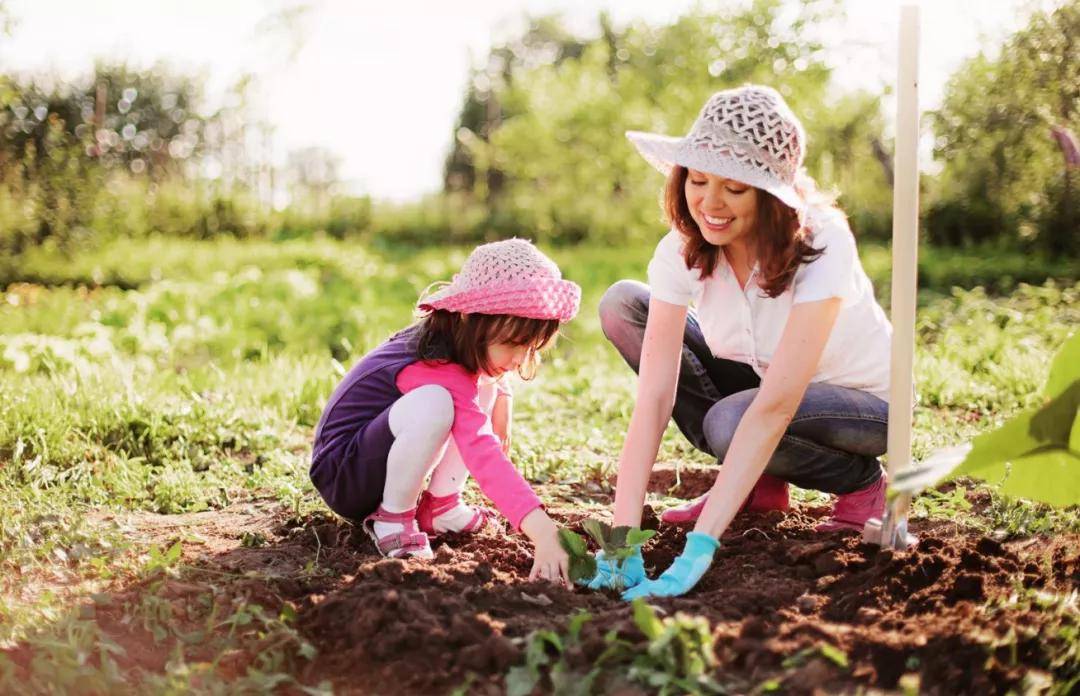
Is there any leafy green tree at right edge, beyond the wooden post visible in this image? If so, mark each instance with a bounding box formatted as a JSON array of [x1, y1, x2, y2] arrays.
[[929, 0, 1080, 249]]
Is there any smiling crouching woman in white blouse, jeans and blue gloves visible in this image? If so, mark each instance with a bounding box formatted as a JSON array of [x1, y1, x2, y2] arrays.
[[593, 85, 892, 599]]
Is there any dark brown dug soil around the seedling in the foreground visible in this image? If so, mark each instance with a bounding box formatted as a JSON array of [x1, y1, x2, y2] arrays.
[[10, 494, 1080, 694]]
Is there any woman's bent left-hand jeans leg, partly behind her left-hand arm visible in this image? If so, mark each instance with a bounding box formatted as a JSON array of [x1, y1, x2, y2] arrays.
[[599, 280, 761, 453]]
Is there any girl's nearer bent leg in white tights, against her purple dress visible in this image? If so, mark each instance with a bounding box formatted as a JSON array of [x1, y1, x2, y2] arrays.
[[375, 385, 454, 537]]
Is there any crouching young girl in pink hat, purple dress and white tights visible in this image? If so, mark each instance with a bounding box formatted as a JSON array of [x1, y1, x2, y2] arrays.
[[311, 239, 581, 583]]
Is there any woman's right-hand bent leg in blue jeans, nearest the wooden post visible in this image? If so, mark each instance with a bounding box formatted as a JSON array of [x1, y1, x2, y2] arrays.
[[704, 384, 889, 528]]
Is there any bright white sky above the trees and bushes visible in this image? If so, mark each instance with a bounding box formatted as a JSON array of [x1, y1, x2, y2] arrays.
[[0, 0, 1054, 200]]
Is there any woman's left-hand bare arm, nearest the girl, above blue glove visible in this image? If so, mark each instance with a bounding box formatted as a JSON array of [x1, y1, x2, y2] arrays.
[[615, 298, 686, 526]]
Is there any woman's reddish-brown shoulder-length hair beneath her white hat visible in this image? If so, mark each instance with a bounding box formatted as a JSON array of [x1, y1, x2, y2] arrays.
[[664, 165, 832, 297]]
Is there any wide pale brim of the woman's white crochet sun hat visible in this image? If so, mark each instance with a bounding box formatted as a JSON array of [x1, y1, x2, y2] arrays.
[[626, 131, 806, 210]]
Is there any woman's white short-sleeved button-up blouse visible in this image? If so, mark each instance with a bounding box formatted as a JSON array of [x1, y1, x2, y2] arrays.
[[649, 209, 892, 401]]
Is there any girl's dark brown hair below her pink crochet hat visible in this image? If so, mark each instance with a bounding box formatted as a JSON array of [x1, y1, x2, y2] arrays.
[[417, 309, 558, 379]]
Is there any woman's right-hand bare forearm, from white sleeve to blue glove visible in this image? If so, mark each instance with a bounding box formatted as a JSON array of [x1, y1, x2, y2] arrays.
[[693, 297, 841, 537]]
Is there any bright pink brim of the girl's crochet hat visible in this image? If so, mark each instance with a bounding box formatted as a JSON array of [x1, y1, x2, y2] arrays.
[[417, 279, 581, 322]]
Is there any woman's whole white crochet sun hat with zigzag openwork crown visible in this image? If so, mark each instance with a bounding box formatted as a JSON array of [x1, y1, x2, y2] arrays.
[[626, 84, 806, 210]]
